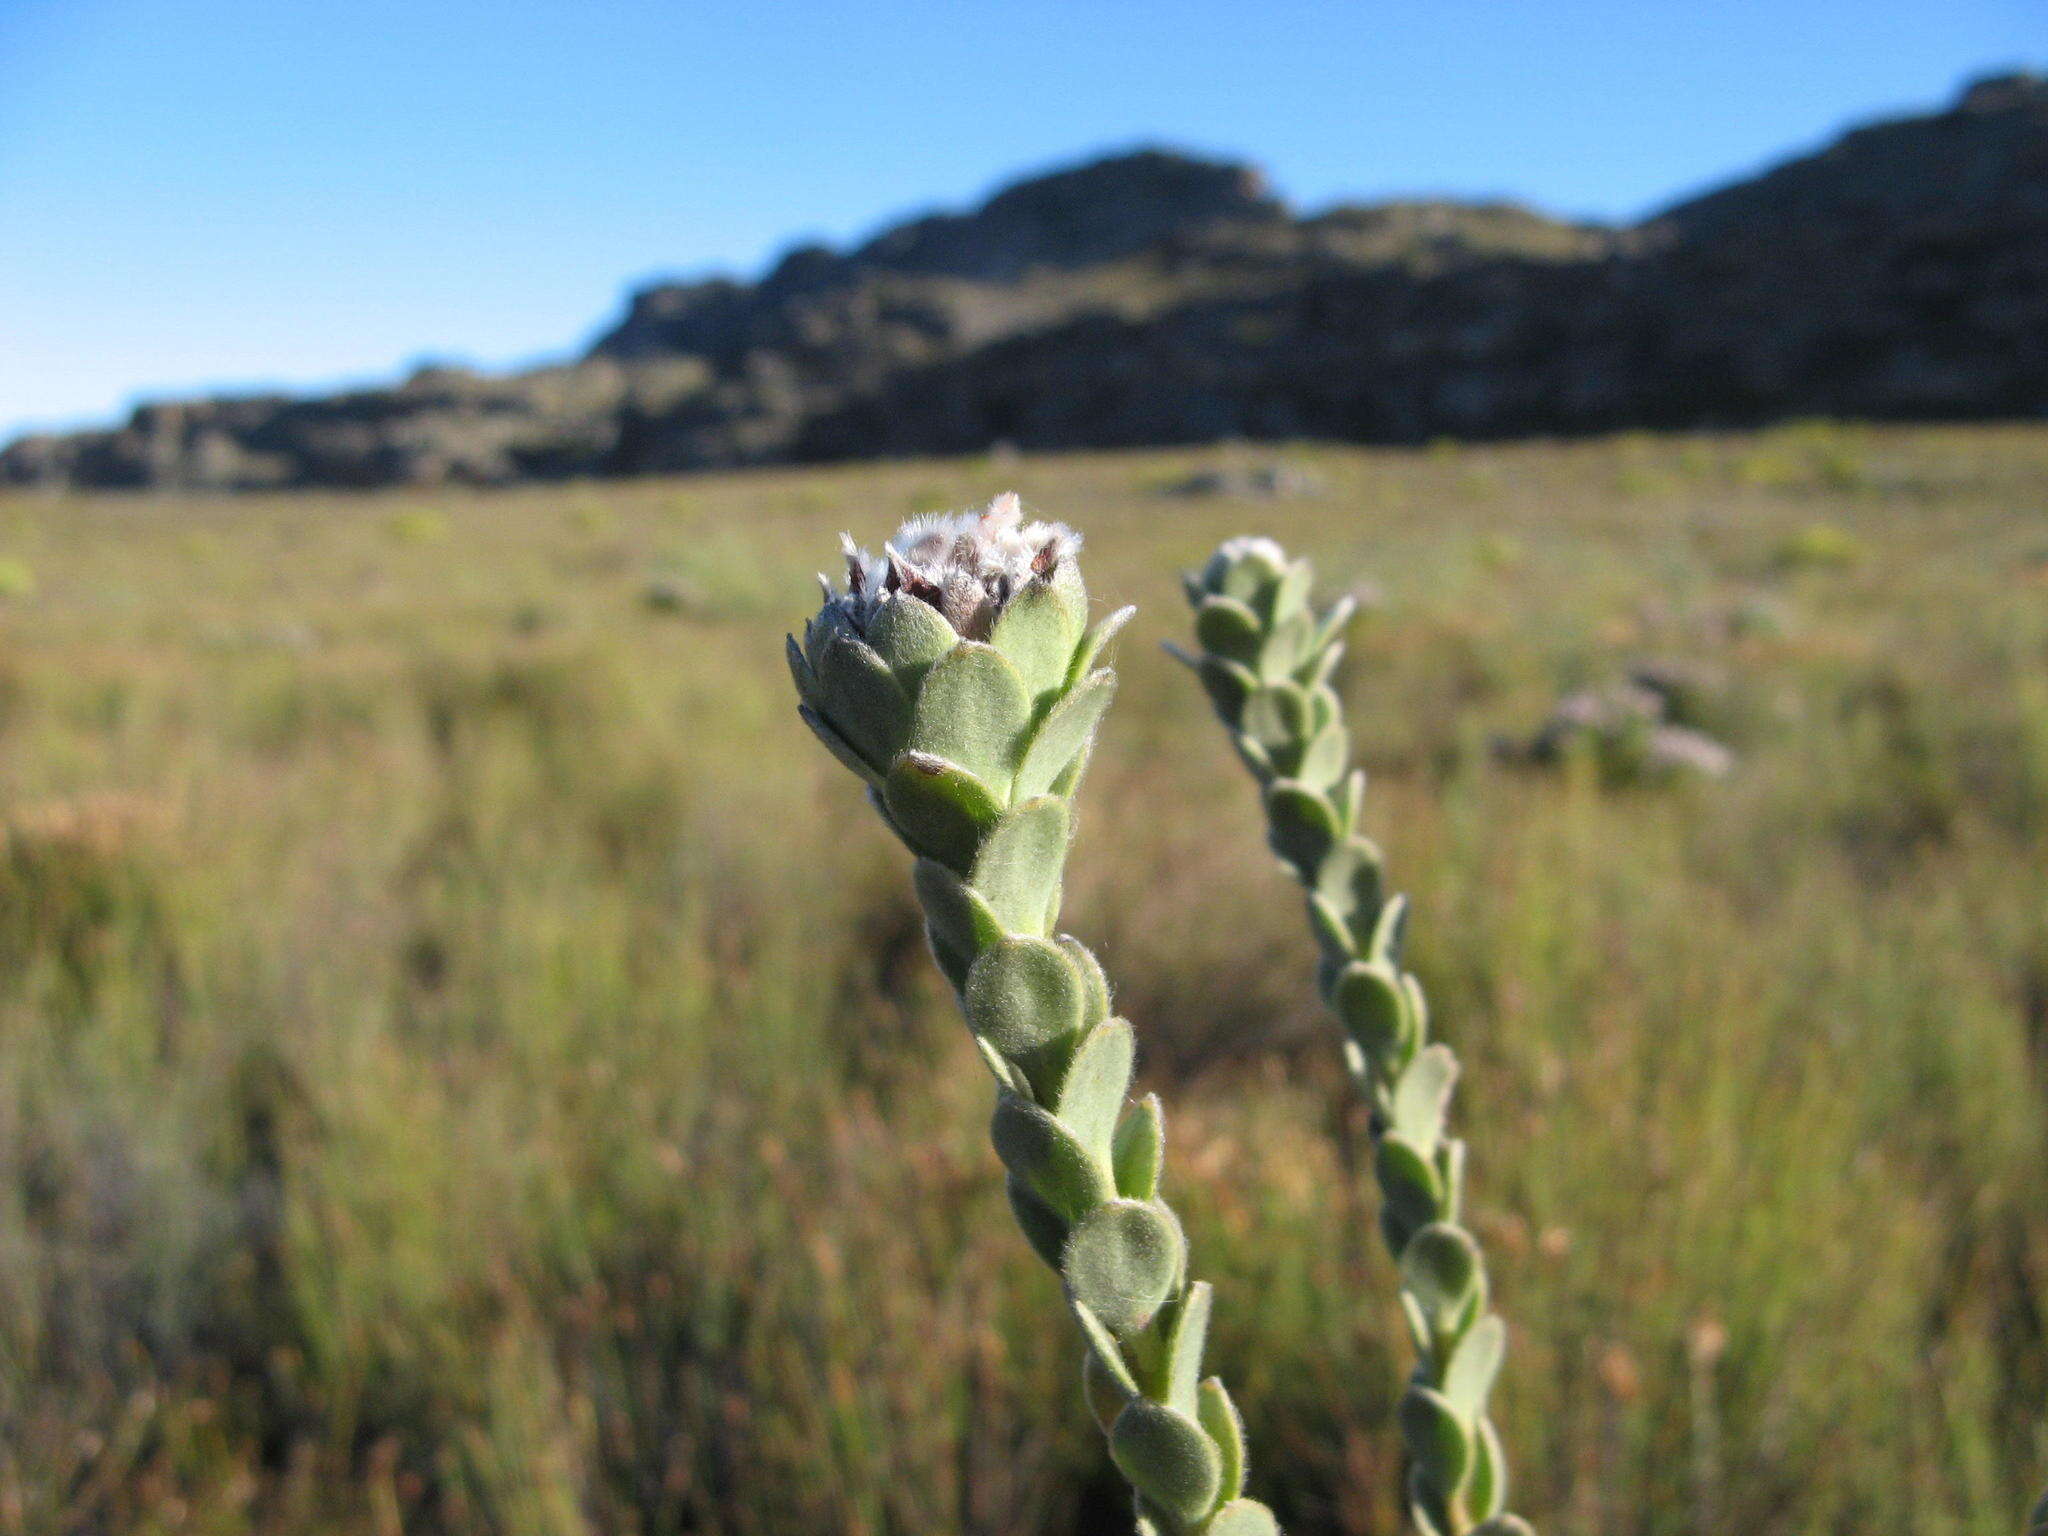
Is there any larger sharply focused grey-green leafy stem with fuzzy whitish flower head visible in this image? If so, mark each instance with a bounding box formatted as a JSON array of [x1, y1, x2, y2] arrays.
[[788, 496, 1278, 1536]]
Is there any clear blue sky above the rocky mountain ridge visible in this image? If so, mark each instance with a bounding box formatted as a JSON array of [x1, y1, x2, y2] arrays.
[[0, 0, 2048, 436]]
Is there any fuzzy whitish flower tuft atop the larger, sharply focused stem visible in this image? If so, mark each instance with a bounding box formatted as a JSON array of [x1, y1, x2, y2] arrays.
[[825, 492, 1081, 639]]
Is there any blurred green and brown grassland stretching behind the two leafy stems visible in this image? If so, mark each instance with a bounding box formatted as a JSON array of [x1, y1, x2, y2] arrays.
[[0, 426, 2048, 1536]]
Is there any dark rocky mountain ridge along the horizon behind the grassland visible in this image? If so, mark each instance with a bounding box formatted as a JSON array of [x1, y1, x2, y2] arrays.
[[0, 76, 2048, 487]]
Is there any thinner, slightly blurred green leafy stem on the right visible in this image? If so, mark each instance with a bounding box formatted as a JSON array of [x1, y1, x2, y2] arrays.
[[1176, 539, 1528, 1536]]
